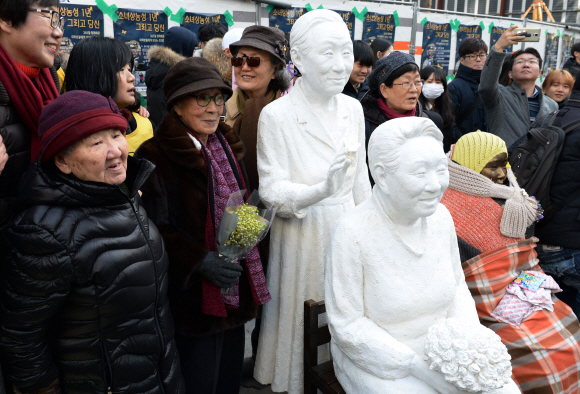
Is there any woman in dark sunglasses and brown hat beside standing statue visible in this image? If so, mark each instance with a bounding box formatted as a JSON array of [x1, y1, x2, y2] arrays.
[[226, 26, 290, 189]]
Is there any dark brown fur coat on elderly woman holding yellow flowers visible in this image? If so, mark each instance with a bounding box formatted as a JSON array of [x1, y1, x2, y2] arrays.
[[135, 114, 258, 336]]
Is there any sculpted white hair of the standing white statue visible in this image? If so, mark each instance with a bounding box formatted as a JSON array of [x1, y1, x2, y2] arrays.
[[290, 9, 348, 54]]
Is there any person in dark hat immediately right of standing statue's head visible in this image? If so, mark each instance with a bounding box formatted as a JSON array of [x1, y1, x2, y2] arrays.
[[342, 40, 375, 101]]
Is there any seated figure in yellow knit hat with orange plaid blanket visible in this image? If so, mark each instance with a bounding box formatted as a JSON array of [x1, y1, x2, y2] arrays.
[[441, 131, 580, 394]]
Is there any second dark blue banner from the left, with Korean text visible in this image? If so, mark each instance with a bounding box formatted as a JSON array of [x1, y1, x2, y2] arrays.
[[114, 8, 167, 68]]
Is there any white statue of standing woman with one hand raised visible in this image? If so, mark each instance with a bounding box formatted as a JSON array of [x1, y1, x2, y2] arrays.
[[254, 10, 371, 394]]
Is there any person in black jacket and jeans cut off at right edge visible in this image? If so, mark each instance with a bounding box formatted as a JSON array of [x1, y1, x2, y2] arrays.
[[536, 79, 580, 316]]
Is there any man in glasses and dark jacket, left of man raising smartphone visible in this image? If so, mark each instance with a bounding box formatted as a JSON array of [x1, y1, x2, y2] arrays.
[[449, 38, 487, 139]]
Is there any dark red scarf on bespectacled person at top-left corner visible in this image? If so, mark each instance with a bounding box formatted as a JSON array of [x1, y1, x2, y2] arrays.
[[0, 45, 58, 162]]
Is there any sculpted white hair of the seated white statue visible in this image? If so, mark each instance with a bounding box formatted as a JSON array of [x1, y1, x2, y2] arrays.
[[368, 116, 443, 179]]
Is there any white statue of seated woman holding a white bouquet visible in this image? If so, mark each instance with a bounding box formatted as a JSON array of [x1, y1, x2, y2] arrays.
[[325, 118, 520, 394]]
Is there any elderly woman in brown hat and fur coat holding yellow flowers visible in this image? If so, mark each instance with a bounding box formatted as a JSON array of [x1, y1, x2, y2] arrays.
[[136, 58, 270, 394]]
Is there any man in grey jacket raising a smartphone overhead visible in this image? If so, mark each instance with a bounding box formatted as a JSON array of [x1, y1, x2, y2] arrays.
[[479, 25, 558, 146]]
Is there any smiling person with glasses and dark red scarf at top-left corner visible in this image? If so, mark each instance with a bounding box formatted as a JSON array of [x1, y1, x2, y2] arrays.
[[0, 0, 64, 231]]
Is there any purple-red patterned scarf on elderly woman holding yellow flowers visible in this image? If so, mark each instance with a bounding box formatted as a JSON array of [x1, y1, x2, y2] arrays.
[[190, 133, 272, 317]]
